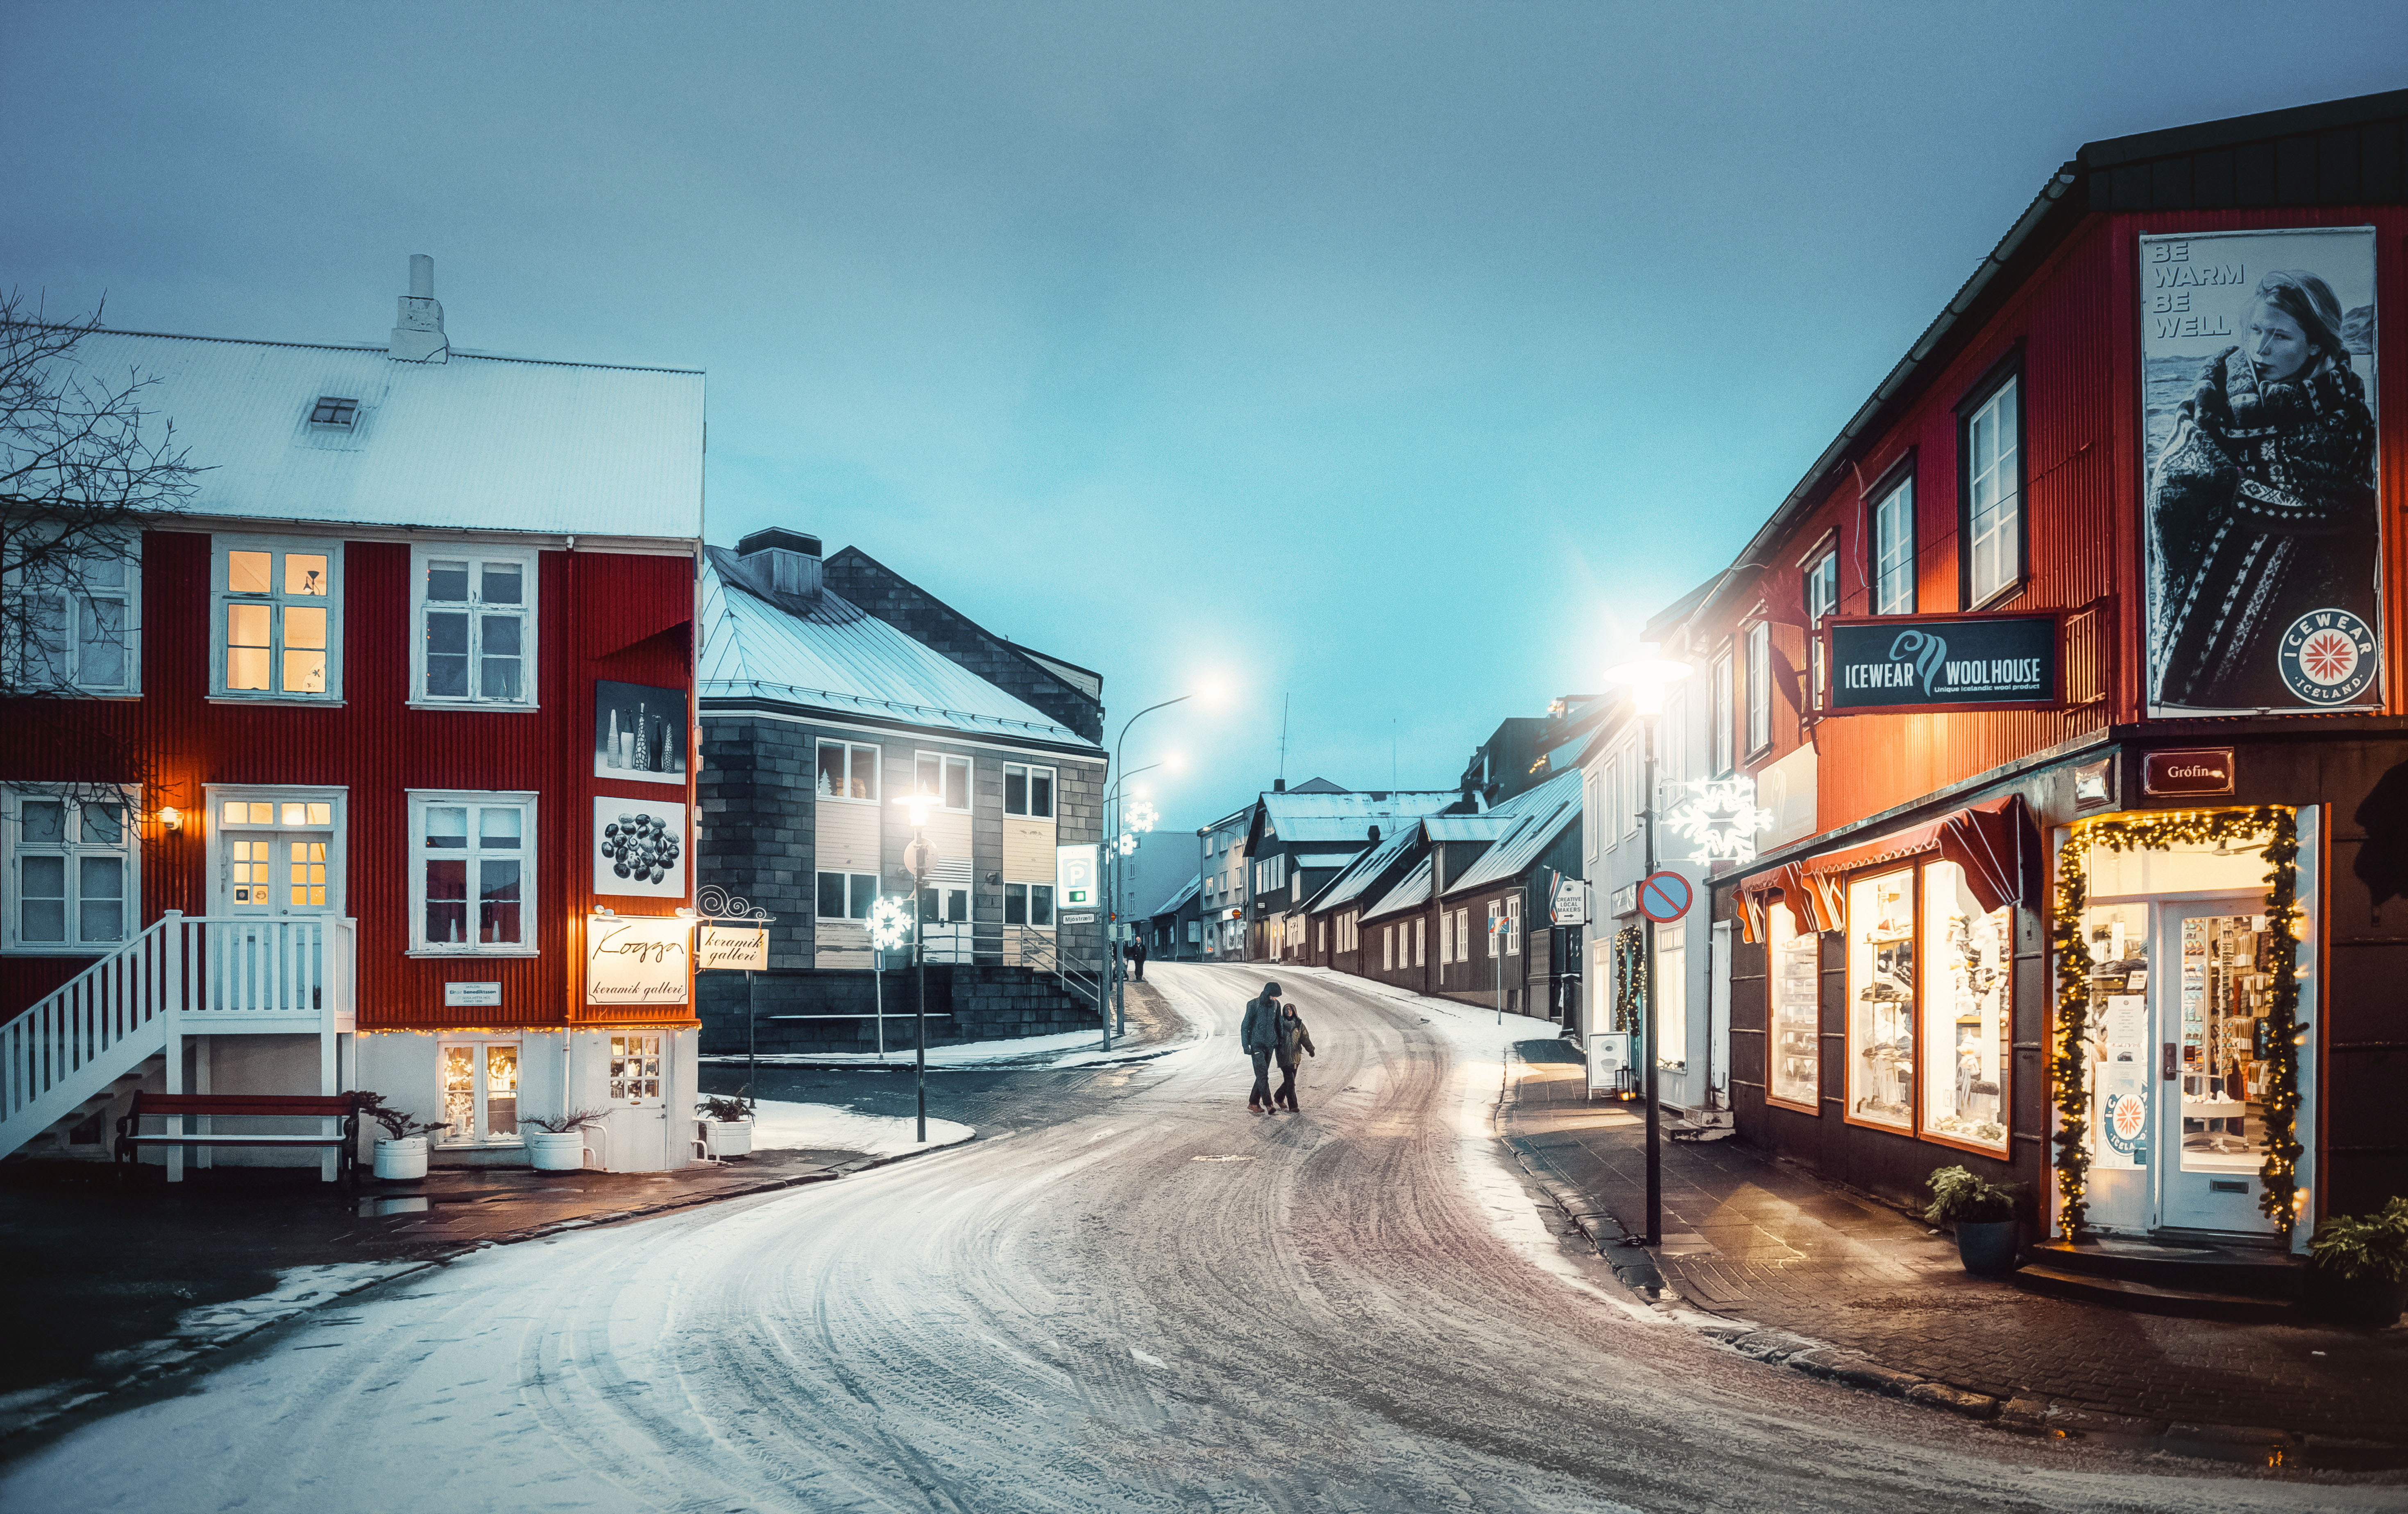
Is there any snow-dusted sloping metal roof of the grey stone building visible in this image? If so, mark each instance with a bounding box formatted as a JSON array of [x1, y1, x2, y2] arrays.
[[698, 546, 1103, 756]]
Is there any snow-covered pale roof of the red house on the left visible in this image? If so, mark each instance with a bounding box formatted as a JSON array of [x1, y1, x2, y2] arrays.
[[72, 332, 703, 542]]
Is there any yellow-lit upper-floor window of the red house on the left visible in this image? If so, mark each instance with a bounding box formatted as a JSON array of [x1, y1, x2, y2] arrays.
[[209, 537, 342, 700]]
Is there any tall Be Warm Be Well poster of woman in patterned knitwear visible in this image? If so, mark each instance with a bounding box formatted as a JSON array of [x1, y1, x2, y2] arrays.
[[2141, 226, 2386, 715]]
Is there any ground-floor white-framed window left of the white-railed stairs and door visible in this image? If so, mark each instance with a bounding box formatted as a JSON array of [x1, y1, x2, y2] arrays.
[[0, 789, 140, 951]]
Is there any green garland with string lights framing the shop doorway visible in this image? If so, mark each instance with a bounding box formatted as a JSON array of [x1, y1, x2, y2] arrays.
[[2049, 804, 2302, 1240]]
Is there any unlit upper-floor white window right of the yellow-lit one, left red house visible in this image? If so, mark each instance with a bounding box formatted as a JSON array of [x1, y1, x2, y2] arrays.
[[409, 546, 535, 705]]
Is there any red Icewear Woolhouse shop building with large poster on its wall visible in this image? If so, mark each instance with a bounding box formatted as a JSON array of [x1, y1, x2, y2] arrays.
[[1659, 91, 2408, 1249]]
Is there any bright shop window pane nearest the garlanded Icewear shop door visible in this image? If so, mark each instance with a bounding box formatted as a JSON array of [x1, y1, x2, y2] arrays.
[[1922, 862, 2016, 1155]]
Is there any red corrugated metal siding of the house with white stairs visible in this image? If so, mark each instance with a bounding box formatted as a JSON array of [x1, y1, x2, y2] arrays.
[[0, 532, 694, 1030]]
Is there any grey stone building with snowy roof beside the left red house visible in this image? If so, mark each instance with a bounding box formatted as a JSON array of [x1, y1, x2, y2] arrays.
[[696, 530, 1105, 1054]]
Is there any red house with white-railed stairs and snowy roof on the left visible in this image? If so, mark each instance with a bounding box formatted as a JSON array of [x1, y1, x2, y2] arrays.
[[0, 260, 703, 1170]]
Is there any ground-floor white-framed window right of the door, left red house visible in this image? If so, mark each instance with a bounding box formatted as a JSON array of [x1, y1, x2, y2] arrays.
[[409, 789, 537, 953]]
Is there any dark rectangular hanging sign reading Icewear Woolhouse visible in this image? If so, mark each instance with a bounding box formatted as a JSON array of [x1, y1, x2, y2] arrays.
[[1823, 614, 2063, 715]]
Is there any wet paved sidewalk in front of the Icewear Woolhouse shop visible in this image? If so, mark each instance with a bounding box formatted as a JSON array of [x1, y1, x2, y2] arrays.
[[1498, 1042, 2408, 1466]]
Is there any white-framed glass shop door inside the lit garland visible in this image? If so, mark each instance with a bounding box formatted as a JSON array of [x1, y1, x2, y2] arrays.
[[2148, 895, 2276, 1235]]
